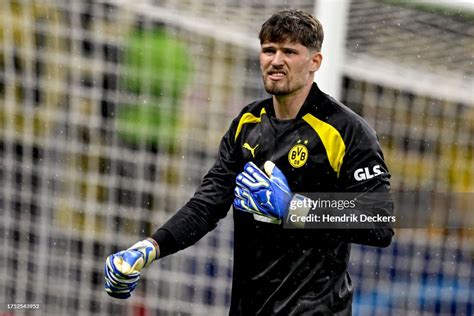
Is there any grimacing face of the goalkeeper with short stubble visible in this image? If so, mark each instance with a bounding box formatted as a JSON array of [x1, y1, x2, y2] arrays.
[[260, 42, 321, 95]]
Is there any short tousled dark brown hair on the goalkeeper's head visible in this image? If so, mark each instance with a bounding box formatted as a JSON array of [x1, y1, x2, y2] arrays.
[[258, 9, 324, 51]]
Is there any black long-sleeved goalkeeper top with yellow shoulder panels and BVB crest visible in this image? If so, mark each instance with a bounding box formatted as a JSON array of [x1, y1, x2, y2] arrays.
[[152, 84, 393, 315]]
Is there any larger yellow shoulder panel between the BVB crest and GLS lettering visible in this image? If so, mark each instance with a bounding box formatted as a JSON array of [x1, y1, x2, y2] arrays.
[[303, 114, 346, 177]]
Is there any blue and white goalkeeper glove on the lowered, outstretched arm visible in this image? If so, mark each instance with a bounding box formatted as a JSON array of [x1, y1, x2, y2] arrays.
[[104, 238, 159, 299]]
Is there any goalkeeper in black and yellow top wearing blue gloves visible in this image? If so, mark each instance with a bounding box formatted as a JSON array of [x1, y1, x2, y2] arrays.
[[105, 10, 393, 315]]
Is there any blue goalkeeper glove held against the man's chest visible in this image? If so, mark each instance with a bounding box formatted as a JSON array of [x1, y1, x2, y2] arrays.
[[234, 161, 292, 224]]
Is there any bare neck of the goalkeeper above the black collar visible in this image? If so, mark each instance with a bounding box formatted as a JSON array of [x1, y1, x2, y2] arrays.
[[273, 82, 312, 120]]
